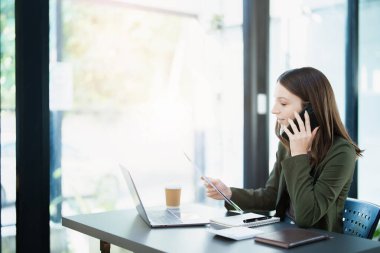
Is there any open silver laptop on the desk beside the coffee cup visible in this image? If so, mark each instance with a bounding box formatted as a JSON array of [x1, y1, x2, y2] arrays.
[[120, 165, 210, 228]]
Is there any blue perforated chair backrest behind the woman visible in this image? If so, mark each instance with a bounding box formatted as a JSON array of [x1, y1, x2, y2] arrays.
[[343, 198, 380, 239]]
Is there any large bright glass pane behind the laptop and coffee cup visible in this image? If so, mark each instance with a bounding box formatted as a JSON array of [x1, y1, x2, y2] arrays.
[[50, 0, 243, 252]]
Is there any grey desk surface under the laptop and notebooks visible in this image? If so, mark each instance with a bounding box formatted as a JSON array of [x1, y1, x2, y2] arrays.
[[62, 206, 380, 253]]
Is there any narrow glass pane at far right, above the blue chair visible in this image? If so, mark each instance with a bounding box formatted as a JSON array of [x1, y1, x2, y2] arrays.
[[358, 0, 380, 204]]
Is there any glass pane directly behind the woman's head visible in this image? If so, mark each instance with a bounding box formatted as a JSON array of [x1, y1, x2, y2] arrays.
[[270, 0, 347, 169]]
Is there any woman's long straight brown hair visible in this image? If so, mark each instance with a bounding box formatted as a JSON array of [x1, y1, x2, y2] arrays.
[[276, 67, 363, 166]]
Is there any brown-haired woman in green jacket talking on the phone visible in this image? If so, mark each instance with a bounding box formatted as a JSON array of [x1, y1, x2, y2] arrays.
[[205, 67, 362, 233]]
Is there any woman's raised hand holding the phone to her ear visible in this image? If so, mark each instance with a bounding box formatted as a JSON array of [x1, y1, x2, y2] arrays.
[[283, 111, 319, 156]]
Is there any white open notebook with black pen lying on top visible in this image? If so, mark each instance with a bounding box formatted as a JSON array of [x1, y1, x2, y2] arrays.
[[210, 213, 280, 229]]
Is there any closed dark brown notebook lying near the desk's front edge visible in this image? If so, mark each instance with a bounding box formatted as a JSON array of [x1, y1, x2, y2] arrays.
[[255, 228, 329, 248]]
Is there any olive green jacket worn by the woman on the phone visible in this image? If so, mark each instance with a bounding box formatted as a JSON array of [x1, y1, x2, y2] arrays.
[[226, 137, 357, 233]]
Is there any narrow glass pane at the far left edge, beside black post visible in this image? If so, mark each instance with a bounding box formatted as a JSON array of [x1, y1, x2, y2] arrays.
[[0, 0, 16, 253]]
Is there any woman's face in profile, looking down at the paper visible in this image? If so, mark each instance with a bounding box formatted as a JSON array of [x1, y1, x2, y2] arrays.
[[272, 83, 302, 126]]
